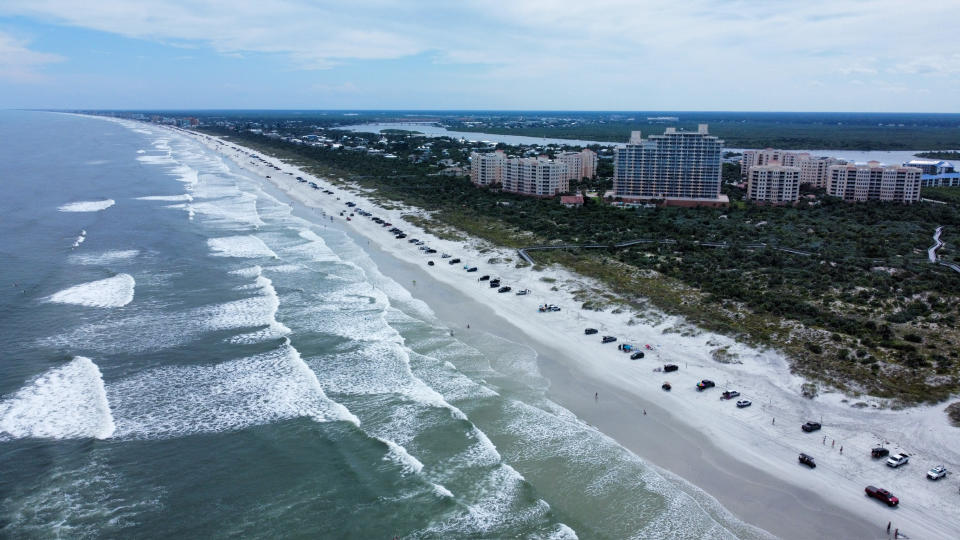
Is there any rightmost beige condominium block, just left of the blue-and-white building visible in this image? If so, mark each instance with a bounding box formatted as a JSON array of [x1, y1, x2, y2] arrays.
[[827, 161, 921, 203]]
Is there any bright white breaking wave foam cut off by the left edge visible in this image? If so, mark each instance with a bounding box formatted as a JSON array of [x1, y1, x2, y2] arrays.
[[0, 356, 114, 439]]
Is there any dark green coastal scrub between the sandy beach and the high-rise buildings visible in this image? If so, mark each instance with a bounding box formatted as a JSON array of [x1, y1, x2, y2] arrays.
[[206, 129, 960, 402]]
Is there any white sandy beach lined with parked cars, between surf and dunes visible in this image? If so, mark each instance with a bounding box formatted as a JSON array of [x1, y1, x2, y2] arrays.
[[182, 132, 960, 538]]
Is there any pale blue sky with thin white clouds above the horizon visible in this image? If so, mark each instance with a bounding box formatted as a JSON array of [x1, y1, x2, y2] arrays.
[[0, 0, 960, 113]]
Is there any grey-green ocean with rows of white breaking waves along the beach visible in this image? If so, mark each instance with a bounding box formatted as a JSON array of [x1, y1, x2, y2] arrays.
[[0, 111, 765, 539]]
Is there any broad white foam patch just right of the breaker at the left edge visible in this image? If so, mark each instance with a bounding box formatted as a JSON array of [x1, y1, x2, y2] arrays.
[[107, 341, 359, 439]]
